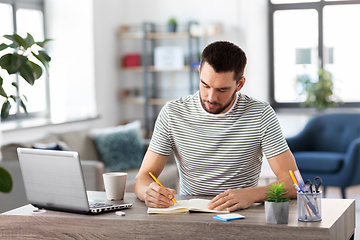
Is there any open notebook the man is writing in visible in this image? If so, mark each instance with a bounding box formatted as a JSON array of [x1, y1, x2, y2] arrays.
[[147, 198, 229, 213]]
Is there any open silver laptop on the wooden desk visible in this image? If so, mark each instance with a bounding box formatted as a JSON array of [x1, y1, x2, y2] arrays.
[[17, 148, 132, 214]]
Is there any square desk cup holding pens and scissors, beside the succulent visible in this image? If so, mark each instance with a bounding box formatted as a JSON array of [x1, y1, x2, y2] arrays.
[[297, 192, 321, 222]]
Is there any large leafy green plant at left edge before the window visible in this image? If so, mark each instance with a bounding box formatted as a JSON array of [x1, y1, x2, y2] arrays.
[[0, 33, 51, 192]]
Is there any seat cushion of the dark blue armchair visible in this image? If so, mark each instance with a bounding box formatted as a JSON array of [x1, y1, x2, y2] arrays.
[[294, 152, 345, 173]]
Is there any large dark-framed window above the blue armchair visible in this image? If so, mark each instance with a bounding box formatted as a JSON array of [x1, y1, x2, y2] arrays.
[[269, 0, 360, 108]]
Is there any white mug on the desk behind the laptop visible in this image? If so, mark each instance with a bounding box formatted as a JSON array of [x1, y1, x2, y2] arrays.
[[103, 172, 127, 201]]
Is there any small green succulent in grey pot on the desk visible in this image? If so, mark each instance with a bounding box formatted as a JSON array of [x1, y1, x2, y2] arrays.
[[265, 182, 290, 224]]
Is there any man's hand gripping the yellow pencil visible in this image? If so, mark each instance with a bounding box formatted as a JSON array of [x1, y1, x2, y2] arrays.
[[145, 182, 176, 208]]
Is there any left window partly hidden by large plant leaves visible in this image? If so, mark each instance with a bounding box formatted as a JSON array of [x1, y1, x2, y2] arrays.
[[0, 0, 50, 120]]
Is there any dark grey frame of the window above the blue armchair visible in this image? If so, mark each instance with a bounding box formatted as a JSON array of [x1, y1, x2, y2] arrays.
[[268, 0, 360, 109]]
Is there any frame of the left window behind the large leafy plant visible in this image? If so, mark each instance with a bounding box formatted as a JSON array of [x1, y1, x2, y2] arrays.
[[0, 0, 50, 122]]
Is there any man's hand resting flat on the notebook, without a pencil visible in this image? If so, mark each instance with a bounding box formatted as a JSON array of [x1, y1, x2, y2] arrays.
[[208, 188, 255, 212]]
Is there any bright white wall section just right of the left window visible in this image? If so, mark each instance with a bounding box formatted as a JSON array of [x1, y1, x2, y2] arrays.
[[45, 0, 97, 122]]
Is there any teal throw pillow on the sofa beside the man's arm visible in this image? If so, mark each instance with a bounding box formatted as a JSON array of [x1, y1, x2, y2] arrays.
[[90, 120, 144, 172]]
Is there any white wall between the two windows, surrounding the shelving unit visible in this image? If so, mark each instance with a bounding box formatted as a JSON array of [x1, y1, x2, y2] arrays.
[[2, 0, 269, 144]]
